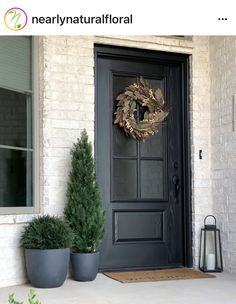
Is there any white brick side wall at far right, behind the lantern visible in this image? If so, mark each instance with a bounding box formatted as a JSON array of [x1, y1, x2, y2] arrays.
[[210, 36, 236, 273]]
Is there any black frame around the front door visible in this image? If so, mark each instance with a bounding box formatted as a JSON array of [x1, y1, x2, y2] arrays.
[[94, 44, 193, 267]]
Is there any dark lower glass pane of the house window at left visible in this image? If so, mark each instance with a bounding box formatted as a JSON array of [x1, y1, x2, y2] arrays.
[[0, 149, 32, 207]]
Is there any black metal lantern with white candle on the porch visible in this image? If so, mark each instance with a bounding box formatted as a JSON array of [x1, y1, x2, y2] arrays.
[[199, 215, 223, 272]]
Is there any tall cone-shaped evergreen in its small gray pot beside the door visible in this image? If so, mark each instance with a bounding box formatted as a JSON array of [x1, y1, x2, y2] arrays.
[[65, 130, 105, 281]]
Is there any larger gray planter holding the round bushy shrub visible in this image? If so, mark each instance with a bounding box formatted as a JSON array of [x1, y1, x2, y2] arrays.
[[25, 248, 70, 288]]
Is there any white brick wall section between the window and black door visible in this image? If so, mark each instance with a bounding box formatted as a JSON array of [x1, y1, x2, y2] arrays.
[[41, 37, 94, 214]]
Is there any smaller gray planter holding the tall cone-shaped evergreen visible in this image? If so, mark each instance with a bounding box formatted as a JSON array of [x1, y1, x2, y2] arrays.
[[71, 252, 99, 281]]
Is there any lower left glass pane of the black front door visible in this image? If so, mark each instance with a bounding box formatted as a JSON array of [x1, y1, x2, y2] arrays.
[[113, 159, 137, 200]]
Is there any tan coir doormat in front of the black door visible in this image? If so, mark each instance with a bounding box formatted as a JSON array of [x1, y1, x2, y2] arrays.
[[104, 268, 215, 283]]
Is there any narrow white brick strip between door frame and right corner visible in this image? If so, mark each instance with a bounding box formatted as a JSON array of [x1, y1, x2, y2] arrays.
[[191, 36, 212, 266]]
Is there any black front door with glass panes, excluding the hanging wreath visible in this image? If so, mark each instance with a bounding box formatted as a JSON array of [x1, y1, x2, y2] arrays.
[[96, 46, 190, 270]]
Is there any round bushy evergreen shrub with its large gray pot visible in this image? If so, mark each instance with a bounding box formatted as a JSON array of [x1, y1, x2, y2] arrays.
[[21, 215, 74, 288]]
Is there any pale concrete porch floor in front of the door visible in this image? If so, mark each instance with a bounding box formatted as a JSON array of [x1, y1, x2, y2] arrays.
[[0, 273, 236, 304]]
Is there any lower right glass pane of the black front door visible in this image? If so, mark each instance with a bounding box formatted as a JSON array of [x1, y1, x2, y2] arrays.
[[140, 160, 164, 199]]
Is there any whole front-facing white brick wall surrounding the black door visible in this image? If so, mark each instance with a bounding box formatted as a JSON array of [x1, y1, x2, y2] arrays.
[[0, 36, 212, 286]]
